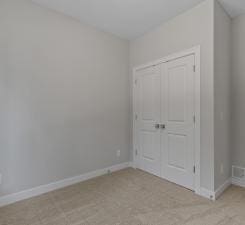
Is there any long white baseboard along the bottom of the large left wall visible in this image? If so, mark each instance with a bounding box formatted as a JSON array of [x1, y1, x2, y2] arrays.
[[0, 162, 132, 207]]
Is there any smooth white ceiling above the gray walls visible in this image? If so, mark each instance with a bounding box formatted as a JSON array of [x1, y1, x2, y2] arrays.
[[33, 0, 245, 39]]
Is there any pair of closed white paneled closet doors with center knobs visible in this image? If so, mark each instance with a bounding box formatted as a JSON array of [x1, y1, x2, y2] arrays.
[[135, 55, 195, 190]]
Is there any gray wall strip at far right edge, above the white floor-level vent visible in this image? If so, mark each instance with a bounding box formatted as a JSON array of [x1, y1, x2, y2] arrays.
[[232, 15, 245, 167]]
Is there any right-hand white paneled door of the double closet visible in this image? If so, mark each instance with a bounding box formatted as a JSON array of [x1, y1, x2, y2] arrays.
[[161, 55, 195, 190]]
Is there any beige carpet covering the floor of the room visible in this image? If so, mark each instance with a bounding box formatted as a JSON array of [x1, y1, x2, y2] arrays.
[[0, 169, 245, 225]]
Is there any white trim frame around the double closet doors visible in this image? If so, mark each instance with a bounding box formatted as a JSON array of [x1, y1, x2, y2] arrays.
[[133, 46, 201, 195]]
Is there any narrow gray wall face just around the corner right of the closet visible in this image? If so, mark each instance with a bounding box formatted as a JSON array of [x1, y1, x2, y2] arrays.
[[214, 1, 231, 190]]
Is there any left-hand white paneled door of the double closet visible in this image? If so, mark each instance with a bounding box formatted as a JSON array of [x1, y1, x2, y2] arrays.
[[137, 66, 161, 176]]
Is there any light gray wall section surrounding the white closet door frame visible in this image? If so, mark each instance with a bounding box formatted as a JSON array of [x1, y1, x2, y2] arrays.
[[130, 0, 214, 190]]
